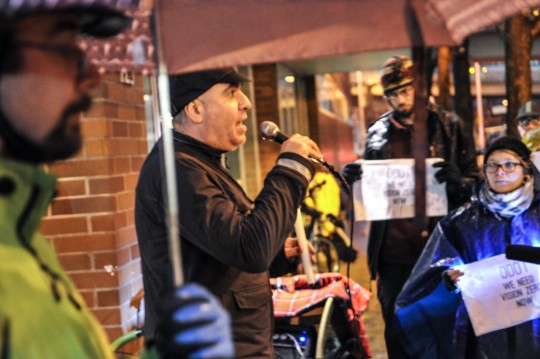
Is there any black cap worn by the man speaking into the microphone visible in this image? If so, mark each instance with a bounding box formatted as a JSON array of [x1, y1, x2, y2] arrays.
[[169, 67, 251, 116]]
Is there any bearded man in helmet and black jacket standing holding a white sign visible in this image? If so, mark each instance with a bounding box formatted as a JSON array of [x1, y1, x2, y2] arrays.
[[342, 56, 478, 359]]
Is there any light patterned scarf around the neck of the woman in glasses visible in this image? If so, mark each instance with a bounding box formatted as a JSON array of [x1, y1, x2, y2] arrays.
[[478, 177, 534, 219]]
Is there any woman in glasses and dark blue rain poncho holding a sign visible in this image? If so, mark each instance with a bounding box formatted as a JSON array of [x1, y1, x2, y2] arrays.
[[396, 137, 540, 359]]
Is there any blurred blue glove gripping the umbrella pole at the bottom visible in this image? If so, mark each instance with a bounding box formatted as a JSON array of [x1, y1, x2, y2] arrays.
[[156, 284, 234, 359]]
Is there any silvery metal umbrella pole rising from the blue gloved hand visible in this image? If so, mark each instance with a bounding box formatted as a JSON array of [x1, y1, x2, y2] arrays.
[[153, 9, 184, 288]]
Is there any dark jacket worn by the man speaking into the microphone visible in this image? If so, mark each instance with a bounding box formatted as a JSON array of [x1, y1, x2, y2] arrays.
[[135, 132, 313, 358]]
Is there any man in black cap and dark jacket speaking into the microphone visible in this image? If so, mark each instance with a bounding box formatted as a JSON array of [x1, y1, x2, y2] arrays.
[[135, 68, 322, 358]]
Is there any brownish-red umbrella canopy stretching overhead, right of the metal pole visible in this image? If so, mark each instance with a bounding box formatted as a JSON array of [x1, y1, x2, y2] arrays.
[[156, 0, 540, 73]]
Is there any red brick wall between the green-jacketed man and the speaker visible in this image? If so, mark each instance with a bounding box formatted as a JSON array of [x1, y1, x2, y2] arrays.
[[41, 74, 147, 340]]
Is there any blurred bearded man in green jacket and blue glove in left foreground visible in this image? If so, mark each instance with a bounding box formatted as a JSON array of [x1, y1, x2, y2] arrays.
[[0, 0, 233, 359]]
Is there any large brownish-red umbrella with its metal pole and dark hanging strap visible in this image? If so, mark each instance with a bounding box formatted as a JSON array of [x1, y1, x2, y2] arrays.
[[56, 0, 540, 284]]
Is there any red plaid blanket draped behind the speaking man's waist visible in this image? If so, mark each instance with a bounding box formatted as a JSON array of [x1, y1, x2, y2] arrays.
[[270, 273, 371, 357]]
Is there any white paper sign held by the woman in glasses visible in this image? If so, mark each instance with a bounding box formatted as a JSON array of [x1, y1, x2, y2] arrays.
[[455, 254, 540, 336]]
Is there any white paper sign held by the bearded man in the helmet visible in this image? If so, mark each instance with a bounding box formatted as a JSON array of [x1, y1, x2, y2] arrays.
[[353, 158, 448, 221]]
